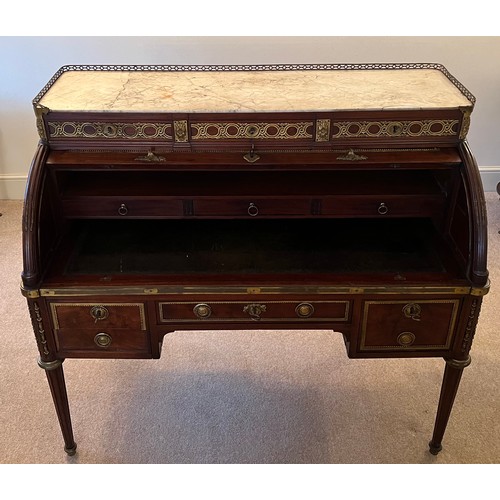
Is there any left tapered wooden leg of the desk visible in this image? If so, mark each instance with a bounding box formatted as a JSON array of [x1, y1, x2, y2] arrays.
[[38, 359, 76, 455]]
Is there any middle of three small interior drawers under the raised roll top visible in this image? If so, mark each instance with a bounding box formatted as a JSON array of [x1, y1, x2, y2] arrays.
[[194, 198, 311, 217]]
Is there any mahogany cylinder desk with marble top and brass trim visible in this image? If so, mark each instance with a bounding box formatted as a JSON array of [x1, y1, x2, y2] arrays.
[[22, 64, 488, 454]]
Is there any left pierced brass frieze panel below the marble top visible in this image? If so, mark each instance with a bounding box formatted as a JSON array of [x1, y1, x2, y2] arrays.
[[48, 122, 172, 140]]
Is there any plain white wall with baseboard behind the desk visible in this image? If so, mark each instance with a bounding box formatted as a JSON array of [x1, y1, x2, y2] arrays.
[[0, 36, 500, 199]]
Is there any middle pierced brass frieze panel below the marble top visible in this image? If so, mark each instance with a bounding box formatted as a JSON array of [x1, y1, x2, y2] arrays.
[[191, 122, 313, 140]]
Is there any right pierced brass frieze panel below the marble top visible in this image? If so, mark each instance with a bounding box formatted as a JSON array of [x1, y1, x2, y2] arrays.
[[332, 120, 459, 139]]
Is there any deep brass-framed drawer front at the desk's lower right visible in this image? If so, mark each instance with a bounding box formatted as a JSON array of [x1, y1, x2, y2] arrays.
[[360, 299, 460, 351]]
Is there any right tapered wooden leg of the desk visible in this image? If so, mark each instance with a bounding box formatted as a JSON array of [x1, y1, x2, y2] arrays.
[[429, 356, 471, 455]]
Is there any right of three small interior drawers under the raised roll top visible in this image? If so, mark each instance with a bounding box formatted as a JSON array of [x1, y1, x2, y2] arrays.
[[321, 195, 444, 217]]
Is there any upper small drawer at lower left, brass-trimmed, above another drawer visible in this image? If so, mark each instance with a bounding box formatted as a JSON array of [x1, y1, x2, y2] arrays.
[[50, 302, 146, 331]]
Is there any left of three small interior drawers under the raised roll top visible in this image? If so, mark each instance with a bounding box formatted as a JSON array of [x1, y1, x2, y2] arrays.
[[62, 196, 184, 218]]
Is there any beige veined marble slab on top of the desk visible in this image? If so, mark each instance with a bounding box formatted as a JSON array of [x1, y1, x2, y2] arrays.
[[40, 69, 471, 113]]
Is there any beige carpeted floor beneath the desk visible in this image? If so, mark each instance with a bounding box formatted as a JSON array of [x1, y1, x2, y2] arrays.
[[0, 193, 500, 464]]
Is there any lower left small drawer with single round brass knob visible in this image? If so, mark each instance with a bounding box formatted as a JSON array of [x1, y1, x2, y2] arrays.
[[57, 328, 149, 357]]
